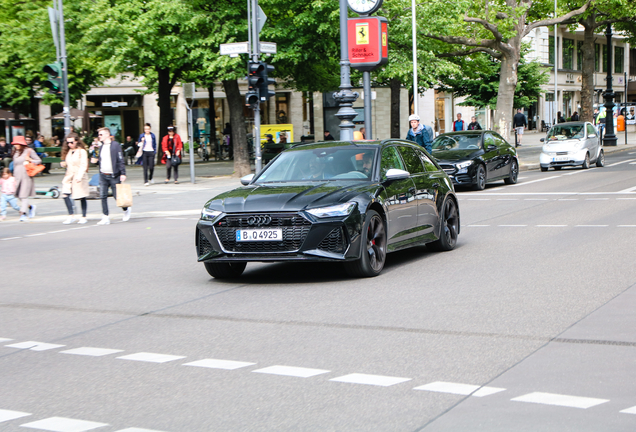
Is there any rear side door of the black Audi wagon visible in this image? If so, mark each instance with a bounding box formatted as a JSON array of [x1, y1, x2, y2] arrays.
[[398, 146, 439, 240]]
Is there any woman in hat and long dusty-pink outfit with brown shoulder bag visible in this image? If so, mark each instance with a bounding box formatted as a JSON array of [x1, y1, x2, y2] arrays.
[[11, 136, 42, 222]]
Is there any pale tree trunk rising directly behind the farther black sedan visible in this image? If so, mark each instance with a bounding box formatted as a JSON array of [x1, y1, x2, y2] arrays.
[[493, 49, 520, 142]]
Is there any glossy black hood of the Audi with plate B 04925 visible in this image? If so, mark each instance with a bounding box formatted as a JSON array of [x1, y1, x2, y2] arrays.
[[206, 181, 370, 213]]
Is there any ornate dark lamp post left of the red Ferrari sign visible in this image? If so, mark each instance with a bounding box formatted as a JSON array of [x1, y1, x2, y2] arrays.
[[333, 0, 358, 141]]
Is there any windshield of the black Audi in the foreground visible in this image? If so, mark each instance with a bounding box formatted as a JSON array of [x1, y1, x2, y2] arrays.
[[255, 146, 377, 183]]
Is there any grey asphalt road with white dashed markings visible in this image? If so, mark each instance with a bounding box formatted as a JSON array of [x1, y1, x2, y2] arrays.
[[0, 151, 636, 432]]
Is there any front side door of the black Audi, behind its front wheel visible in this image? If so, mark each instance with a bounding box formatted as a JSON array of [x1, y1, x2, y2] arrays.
[[380, 146, 417, 245]]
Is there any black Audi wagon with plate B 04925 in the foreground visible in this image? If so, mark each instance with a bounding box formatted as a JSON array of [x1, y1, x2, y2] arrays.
[[195, 140, 459, 278]]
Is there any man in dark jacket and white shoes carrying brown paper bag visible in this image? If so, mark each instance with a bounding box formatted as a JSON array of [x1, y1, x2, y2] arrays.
[[91, 127, 131, 225]]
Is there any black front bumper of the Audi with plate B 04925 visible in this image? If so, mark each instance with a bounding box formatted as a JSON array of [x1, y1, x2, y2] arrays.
[[195, 208, 363, 262]]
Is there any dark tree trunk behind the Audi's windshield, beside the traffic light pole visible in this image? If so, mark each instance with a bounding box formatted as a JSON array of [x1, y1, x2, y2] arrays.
[[223, 79, 250, 177]]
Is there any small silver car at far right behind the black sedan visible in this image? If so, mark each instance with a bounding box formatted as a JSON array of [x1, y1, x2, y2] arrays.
[[539, 122, 605, 171]]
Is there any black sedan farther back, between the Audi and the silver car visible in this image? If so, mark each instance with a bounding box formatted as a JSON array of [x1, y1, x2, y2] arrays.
[[433, 130, 519, 190]]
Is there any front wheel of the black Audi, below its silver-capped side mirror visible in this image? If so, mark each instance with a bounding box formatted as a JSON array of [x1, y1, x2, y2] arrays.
[[345, 210, 386, 277]]
